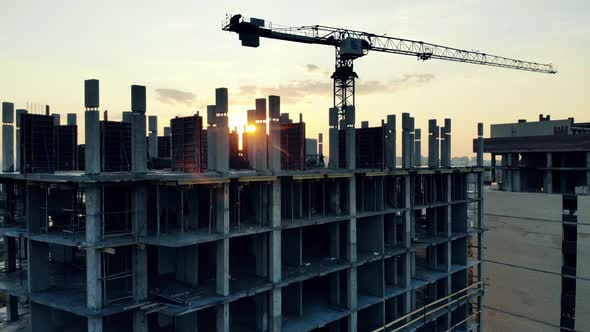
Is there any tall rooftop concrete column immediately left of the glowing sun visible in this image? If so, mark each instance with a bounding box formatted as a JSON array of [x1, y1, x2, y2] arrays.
[[215, 88, 229, 172]]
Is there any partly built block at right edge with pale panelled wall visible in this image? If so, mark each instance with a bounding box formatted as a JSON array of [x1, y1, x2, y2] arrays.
[[484, 115, 590, 331]]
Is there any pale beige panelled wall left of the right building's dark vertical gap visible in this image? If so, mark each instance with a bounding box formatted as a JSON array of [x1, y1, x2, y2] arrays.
[[484, 191, 562, 331]]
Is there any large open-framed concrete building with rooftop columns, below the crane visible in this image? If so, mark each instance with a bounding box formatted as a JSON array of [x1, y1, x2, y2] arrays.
[[0, 80, 483, 332]]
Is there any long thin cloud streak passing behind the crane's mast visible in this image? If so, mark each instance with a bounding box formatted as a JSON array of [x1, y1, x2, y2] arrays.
[[237, 73, 435, 104]]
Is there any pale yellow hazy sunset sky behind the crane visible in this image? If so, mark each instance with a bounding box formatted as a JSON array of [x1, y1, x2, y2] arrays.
[[0, 1, 590, 155]]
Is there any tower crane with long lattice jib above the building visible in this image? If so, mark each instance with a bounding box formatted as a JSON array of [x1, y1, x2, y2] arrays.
[[222, 14, 557, 123]]
